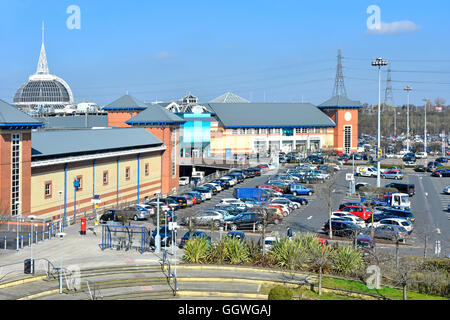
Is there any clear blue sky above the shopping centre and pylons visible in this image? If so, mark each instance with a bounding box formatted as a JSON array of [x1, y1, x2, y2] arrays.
[[0, 0, 450, 105]]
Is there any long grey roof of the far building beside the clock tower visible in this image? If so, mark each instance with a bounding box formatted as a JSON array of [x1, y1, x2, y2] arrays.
[[208, 103, 336, 128]]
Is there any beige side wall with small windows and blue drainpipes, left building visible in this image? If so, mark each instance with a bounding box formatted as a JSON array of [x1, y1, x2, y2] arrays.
[[31, 152, 161, 218]]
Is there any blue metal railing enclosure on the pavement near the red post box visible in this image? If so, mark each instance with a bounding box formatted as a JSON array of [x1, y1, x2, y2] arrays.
[[100, 225, 150, 254]]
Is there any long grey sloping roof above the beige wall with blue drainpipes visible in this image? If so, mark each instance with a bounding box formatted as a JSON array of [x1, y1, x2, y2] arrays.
[[31, 128, 162, 158]]
